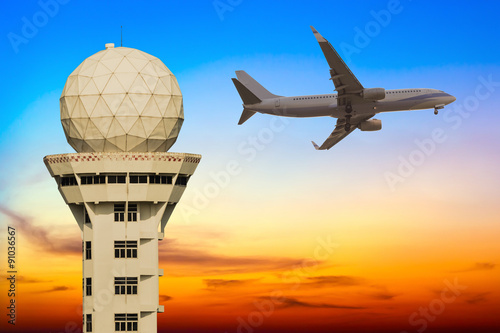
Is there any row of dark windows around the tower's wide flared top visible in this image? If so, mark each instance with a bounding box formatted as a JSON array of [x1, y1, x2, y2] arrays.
[[60, 174, 189, 186]]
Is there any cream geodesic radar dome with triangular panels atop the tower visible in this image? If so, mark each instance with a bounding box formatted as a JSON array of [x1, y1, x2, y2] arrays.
[[60, 44, 184, 153]]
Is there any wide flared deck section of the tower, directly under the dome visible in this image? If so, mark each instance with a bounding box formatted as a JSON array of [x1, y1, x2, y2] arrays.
[[44, 152, 201, 204]]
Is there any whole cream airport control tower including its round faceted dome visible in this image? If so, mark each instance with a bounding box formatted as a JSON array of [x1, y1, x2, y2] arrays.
[[44, 44, 201, 333]]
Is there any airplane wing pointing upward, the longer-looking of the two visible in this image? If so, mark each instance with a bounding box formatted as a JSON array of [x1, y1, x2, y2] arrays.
[[311, 26, 363, 100]]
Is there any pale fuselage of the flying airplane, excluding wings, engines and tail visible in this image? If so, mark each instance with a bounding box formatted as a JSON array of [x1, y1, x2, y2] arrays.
[[244, 88, 455, 118]]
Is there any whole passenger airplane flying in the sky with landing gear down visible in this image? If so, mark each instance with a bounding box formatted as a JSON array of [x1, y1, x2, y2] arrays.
[[232, 26, 456, 150]]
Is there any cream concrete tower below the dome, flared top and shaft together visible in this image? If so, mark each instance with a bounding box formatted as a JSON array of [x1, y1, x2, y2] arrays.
[[44, 152, 201, 332]]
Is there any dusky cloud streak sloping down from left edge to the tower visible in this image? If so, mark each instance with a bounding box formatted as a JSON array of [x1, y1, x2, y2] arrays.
[[0, 205, 82, 255]]
